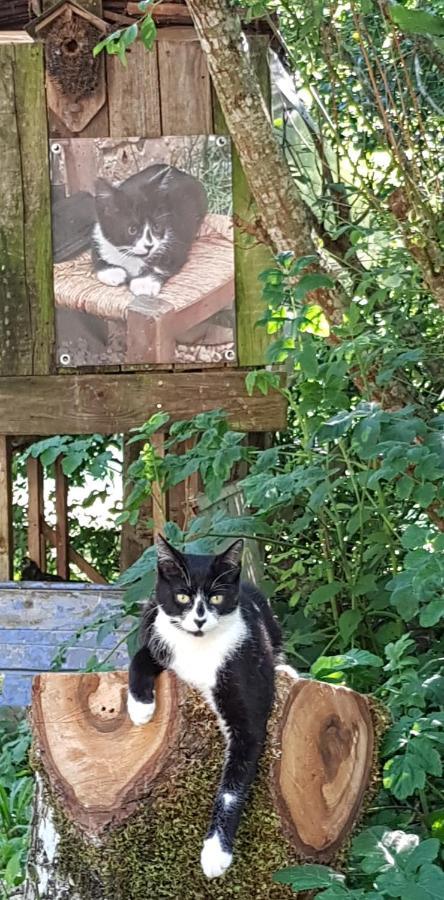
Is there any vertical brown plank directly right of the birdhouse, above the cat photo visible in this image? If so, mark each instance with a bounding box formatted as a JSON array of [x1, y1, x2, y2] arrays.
[[106, 43, 161, 137]]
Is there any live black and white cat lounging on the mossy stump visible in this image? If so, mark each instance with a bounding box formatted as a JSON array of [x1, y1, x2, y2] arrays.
[[128, 538, 282, 878]]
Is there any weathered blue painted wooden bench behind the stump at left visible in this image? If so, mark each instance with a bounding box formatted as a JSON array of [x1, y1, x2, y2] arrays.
[[0, 582, 135, 707]]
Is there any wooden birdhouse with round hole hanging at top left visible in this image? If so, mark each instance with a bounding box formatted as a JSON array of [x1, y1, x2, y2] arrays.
[[28, 0, 107, 134]]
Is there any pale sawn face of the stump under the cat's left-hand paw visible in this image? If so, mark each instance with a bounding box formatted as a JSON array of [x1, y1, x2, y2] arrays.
[[32, 672, 179, 834]]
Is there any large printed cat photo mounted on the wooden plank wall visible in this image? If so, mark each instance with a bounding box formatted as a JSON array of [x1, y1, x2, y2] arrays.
[[50, 135, 236, 368]]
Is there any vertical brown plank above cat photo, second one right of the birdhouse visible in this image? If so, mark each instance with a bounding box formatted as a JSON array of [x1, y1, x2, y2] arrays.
[[157, 40, 212, 134]]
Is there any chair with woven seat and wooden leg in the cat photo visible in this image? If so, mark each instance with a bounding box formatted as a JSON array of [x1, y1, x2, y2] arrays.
[[54, 214, 234, 364]]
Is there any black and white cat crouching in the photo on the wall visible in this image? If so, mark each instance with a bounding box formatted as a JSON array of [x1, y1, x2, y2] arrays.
[[92, 164, 207, 297]]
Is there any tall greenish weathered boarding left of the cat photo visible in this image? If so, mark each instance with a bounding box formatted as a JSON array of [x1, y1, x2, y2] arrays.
[[0, 42, 54, 375]]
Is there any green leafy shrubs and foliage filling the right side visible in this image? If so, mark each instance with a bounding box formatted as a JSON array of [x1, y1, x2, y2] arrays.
[[0, 0, 444, 900]]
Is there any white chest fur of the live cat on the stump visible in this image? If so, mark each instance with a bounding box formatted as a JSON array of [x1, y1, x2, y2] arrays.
[[154, 609, 248, 701]]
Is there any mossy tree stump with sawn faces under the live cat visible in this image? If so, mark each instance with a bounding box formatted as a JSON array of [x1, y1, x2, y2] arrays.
[[24, 671, 384, 900]]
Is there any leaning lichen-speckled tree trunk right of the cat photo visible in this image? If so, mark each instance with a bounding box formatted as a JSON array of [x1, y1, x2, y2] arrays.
[[187, 0, 342, 322]]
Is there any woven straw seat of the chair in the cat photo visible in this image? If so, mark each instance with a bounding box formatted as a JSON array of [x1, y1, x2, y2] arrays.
[[54, 214, 234, 320]]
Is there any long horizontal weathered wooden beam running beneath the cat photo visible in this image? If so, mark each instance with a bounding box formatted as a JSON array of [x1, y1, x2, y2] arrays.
[[0, 369, 286, 435]]
